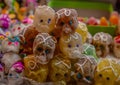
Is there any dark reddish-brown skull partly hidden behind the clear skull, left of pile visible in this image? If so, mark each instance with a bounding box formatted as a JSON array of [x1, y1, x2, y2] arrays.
[[21, 26, 38, 54]]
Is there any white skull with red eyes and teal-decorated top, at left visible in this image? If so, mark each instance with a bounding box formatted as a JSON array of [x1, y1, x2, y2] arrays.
[[2, 36, 20, 53]]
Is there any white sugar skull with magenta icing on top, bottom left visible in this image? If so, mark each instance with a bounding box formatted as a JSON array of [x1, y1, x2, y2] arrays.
[[7, 62, 24, 85]]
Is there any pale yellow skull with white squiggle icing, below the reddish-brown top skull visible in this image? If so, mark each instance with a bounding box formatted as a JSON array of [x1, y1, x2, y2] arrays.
[[59, 33, 83, 59]]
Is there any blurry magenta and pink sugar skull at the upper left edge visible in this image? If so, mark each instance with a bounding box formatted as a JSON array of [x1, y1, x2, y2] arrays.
[[0, 14, 10, 29]]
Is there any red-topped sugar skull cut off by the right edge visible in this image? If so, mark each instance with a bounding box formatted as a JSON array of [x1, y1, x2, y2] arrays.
[[113, 36, 120, 58]]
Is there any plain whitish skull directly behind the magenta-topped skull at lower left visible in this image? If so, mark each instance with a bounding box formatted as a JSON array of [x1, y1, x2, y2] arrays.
[[1, 52, 21, 73]]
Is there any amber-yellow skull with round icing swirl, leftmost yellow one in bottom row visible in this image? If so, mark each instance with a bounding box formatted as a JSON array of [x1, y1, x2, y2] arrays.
[[24, 55, 48, 82]]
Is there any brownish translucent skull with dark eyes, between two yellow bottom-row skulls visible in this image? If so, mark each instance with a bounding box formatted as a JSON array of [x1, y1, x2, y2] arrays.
[[74, 55, 97, 85]]
